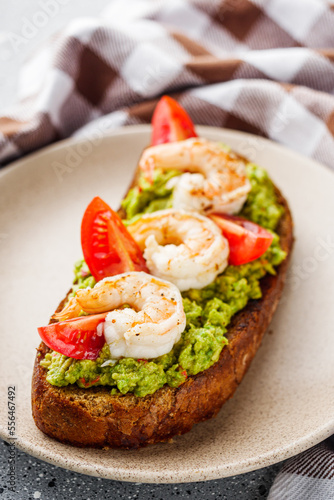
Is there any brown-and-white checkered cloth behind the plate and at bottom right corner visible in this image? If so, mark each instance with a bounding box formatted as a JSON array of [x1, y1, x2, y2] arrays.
[[0, 0, 334, 494]]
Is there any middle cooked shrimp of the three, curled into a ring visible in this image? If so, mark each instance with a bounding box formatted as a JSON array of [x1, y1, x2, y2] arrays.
[[127, 209, 229, 291]]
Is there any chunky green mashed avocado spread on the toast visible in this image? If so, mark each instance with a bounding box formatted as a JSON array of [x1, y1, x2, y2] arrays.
[[41, 164, 286, 397]]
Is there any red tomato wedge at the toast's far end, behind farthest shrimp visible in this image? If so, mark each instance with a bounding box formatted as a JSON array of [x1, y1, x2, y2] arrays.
[[151, 95, 197, 146]]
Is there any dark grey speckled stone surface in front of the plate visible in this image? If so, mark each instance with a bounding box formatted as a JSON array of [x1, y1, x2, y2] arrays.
[[0, 441, 282, 500]]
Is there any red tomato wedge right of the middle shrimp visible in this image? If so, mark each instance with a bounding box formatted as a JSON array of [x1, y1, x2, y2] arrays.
[[209, 214, 273, 266]]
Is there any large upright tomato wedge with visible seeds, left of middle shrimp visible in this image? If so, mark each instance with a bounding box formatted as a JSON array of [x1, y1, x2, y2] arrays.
[[81, 196, 149, 281]]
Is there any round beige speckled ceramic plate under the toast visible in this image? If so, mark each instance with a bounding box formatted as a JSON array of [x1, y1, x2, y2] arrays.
[[0, 126, 334, 483]]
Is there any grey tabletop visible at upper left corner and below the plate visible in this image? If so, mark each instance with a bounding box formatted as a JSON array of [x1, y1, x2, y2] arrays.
[[0, 0, 281, 500]]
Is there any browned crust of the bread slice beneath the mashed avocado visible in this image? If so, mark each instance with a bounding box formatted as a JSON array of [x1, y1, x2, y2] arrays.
[[32, 182, 293, 449]]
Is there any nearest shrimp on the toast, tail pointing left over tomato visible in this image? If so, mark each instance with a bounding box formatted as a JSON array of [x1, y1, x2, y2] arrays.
[[55, 272, 186, 359]]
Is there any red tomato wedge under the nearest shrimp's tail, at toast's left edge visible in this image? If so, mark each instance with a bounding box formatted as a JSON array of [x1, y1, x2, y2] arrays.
[[38, 313, 108, 359]]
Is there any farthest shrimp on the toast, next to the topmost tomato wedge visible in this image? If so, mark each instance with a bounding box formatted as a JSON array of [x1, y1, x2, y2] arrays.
[[139, 138, 251, 214]]
